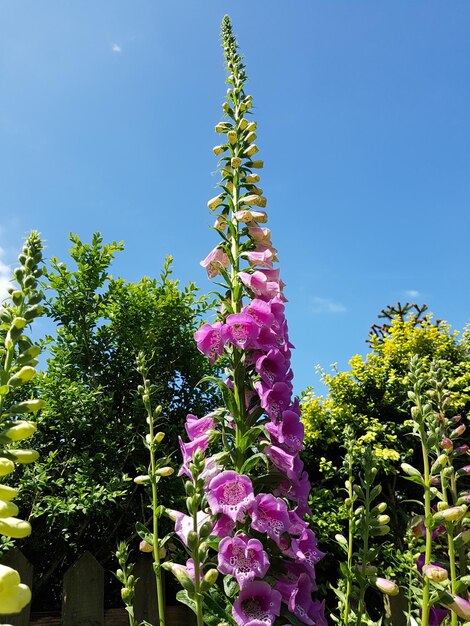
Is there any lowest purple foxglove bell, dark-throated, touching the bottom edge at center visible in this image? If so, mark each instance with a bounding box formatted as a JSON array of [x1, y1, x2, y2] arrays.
[[232, 581, 281, 626]]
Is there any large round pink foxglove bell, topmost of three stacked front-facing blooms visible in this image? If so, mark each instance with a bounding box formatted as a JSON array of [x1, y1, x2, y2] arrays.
[[207, 470, 255, 522]]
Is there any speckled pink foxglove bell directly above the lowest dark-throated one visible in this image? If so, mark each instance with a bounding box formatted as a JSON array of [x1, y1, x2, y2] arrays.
[[218, 534, 269, 588]]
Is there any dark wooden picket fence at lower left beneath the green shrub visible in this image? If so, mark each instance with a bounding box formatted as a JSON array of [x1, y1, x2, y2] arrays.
[[0, 548, 194, 626]]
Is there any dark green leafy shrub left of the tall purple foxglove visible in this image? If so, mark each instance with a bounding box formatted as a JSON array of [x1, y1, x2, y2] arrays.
[[14, 234, 214, 602]]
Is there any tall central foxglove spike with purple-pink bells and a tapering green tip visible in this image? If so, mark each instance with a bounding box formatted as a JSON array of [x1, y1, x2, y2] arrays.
[[174, 16, 324, 626]]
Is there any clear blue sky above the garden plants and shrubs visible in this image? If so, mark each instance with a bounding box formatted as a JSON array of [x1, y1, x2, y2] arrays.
[[0, 0, 470, 391]]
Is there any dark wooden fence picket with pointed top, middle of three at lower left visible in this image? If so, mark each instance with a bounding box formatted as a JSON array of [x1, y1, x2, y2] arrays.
[[62, 552, 104, 626]]
